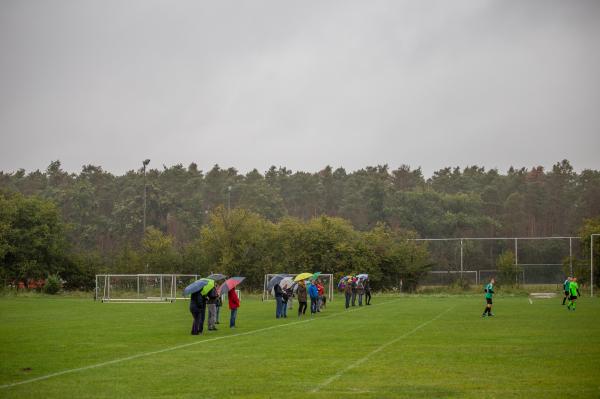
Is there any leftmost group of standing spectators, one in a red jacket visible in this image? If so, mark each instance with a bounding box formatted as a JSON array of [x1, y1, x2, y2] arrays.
[[190, 288, 240, 335]]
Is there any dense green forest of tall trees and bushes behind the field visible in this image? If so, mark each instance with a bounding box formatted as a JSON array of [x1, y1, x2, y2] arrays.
[[0, 160, 600, 289]]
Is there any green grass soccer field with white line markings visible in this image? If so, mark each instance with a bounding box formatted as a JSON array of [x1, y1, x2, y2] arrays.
[[0, 295, 600, 399]]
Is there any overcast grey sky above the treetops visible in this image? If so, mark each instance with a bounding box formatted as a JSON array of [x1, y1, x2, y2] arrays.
[[0, 0, 600, 175]]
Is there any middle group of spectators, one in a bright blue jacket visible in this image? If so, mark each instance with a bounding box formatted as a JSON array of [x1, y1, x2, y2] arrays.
[[273, 279, 327, 319]]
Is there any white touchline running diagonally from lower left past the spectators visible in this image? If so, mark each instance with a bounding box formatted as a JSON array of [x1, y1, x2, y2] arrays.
[[0, 299, 398, 389]]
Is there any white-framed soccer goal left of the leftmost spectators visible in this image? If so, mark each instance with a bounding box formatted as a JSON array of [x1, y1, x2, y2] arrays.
[[95, 274, 199, 303]]
